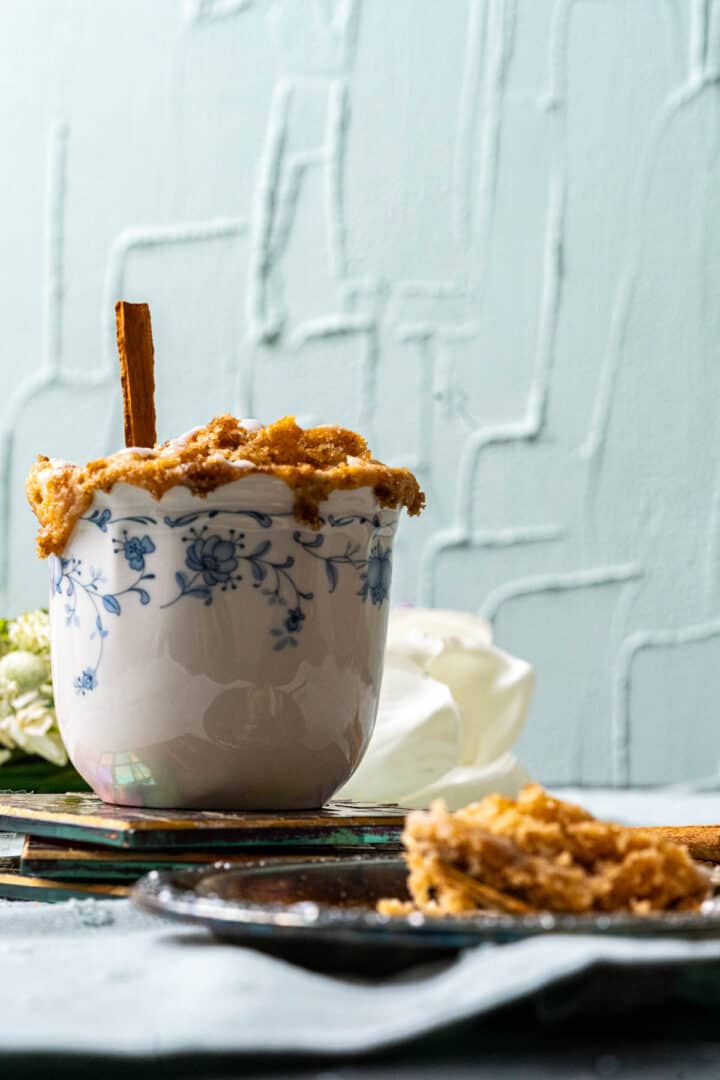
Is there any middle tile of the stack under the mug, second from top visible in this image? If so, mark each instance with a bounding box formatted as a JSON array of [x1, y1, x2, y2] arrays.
[[21, 836, 369, 883]]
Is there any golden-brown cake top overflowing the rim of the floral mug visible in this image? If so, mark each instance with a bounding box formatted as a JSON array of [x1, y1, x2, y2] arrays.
[[26, 416, 425, 558]]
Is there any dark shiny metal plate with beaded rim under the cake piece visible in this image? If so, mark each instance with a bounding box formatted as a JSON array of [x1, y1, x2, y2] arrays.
[[131, 856, 720, 971]]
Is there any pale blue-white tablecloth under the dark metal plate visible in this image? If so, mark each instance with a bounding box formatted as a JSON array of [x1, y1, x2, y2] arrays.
[[0, 793, 720, 1056]]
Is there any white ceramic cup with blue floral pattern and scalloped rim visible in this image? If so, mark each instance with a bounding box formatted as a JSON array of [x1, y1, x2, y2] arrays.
[[50, 475, 398, 810]]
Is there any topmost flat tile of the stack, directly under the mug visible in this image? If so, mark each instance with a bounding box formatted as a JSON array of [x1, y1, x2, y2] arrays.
[[0, 792, 407, 851]]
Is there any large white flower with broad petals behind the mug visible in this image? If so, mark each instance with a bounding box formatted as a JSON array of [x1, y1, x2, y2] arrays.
[[338, 608, 534, 810]]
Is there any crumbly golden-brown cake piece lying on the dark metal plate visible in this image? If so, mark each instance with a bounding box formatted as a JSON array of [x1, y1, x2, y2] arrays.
[[378, 784, 710, 916]]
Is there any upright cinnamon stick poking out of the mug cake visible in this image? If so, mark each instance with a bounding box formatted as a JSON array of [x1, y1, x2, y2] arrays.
[[116, 300, 157, 446]]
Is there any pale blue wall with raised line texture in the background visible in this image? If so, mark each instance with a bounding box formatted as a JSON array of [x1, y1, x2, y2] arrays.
[[0, 0, 720, 783]]
